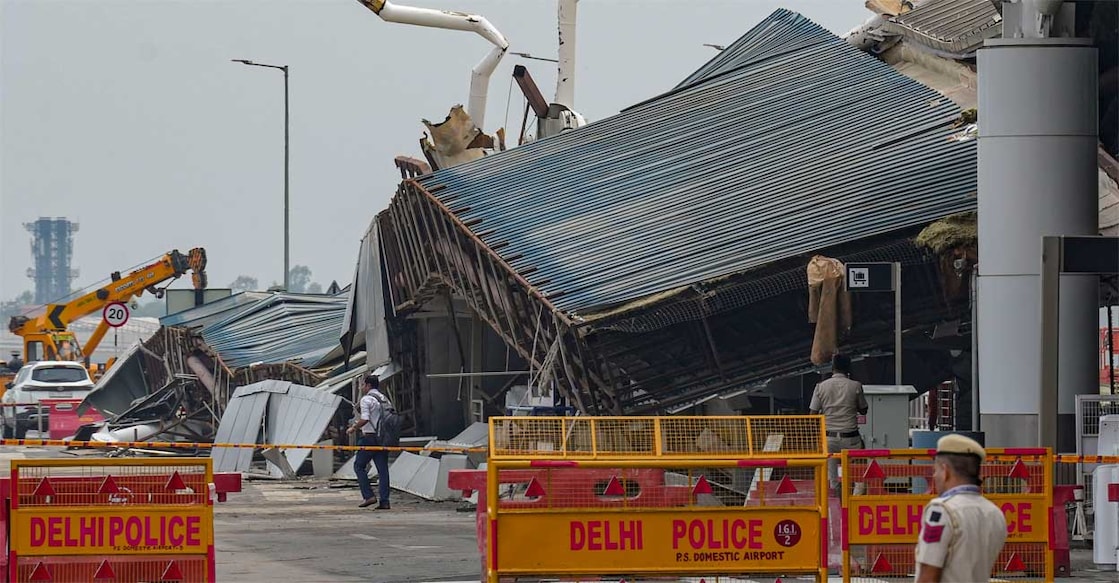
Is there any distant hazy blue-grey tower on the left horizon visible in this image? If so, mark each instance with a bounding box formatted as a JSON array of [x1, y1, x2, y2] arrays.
[[23, 217, 77, 303]]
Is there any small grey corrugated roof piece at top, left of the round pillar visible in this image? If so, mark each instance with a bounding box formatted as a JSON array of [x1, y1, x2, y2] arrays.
[[884, 0, 1003, 56]]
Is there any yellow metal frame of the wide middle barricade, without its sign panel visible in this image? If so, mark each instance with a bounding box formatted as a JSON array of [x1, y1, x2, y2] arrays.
[[483, 415, 828, 583]]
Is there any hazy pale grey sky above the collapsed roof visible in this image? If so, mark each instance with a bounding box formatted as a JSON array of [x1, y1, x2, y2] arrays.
[[0, 0, 871, 299]]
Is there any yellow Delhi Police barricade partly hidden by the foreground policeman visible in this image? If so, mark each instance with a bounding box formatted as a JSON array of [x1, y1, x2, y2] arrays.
[[841, 448, 1053, 581]]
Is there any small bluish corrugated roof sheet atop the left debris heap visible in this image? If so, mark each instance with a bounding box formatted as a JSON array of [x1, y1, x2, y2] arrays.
[[200, 293, 347, 367]]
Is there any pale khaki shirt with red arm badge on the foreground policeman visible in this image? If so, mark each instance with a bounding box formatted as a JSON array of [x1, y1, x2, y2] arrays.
[[916, 486, 1006, 583]]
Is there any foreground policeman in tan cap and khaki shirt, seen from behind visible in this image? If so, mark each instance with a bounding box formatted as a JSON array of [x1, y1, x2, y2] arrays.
[[916, 435, 1006, 583]]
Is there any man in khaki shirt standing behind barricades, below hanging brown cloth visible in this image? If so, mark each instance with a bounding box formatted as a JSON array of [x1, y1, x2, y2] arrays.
[[808, 354, 869, 489]]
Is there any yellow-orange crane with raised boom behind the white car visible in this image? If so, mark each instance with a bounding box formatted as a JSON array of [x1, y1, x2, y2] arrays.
[[8, 247, 206, 366]]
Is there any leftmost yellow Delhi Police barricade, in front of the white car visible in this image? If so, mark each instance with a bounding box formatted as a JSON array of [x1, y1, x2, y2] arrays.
[[8, 458, 215, 582]]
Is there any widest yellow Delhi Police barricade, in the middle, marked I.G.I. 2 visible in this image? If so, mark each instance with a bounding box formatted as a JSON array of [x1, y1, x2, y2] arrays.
[[485, 416, 827, 582]]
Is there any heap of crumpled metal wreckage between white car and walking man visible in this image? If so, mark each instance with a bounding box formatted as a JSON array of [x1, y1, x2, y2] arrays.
[[75, 292, 375, 477]]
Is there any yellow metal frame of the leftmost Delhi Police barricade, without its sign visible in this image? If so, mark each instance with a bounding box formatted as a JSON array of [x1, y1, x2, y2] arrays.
[[8, 458, 216, 583]]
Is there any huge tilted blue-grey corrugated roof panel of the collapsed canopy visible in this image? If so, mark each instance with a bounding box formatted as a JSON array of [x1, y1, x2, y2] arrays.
[[420, 10, 976, 314]]
